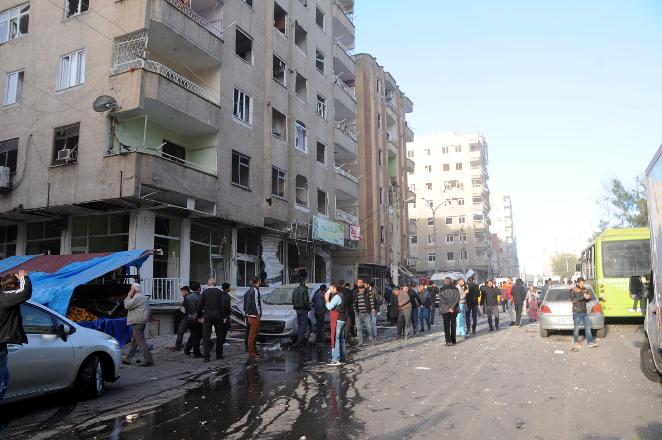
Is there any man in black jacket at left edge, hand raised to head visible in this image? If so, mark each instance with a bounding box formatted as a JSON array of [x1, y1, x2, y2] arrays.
[[0, 270, 32, 400]]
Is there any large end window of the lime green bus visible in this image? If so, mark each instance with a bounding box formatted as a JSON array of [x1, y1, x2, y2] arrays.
[[602, 240, 651, 278]]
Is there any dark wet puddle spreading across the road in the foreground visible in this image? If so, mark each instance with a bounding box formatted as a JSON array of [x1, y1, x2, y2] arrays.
[[59, 347, 361, 440]]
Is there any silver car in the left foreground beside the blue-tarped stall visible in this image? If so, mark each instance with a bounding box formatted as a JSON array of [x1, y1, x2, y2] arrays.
[[0, 301, 122, 404]]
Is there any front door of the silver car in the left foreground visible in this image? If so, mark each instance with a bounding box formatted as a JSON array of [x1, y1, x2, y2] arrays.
[[8, 304, 75, 395]]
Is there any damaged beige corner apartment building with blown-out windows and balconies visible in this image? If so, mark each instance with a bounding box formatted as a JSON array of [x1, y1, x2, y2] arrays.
[[0, 0, 359, 328]]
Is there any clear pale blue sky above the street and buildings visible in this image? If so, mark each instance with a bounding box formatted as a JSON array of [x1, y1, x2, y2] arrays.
[[355, 0, 662, 272]]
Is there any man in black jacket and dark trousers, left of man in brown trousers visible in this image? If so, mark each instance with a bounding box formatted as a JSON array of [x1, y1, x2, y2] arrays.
[[198, 278, 231, 362]]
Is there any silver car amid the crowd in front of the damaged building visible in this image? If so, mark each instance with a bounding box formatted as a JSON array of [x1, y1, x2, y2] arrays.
[[232, 283, 329, 340]]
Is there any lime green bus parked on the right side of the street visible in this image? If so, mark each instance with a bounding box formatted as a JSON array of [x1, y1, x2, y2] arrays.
[[580, 228, 651, 318]]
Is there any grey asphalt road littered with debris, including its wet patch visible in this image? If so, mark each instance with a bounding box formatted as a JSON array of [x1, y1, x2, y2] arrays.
[[0, 315, 662, 440]]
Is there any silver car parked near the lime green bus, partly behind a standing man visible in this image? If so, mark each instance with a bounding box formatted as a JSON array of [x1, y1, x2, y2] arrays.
[[540, 285, 607, 338]]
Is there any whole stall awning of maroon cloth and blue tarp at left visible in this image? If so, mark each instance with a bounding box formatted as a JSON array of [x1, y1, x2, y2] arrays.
[[0, 249, 151, 315]]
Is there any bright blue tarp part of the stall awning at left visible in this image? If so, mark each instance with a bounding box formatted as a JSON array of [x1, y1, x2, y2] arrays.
[[6, 249, 150, 315]]
